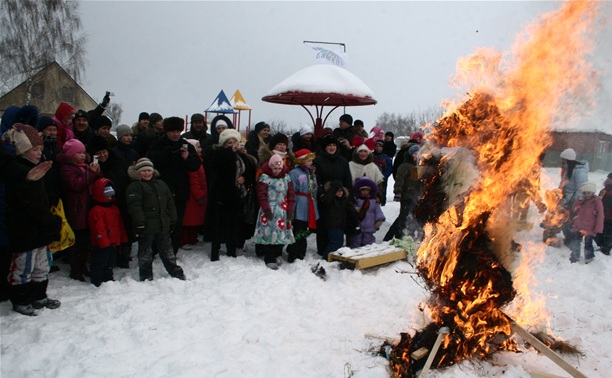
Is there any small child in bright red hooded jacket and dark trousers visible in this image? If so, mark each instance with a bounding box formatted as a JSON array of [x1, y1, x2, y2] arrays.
[[88, 178, 128, 286]]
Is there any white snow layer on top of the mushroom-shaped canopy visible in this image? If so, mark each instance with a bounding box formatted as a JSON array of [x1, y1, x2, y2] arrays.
[[264, 64, 374, 97]]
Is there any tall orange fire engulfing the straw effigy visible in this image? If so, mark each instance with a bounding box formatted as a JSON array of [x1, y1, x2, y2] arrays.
[[390, 1, 598, 377]]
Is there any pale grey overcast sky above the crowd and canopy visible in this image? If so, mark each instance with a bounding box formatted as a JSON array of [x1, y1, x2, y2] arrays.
[[80, 1, 612, 133]]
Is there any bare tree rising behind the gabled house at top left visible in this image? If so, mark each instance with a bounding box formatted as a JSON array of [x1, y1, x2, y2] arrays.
[[0, 0, 87, 102]]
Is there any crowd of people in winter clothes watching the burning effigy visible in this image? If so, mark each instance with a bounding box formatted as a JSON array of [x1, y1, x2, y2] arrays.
[[0, 96, 612, 315]]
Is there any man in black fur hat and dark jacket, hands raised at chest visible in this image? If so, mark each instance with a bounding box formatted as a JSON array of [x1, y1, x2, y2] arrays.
[[147, 117, 200, 254]]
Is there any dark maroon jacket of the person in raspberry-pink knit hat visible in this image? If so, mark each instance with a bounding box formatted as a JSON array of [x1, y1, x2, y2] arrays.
[[57, 153, 101, 231]]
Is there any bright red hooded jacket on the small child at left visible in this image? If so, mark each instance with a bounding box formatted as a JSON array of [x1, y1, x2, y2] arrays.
[[87, 178, 128, 249]]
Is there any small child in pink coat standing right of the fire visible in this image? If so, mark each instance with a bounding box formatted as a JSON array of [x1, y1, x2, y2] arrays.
[[568, 182, 604, 264]]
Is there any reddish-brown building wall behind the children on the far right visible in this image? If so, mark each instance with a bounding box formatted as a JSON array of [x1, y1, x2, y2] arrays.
[[544, 131, 612, 172]]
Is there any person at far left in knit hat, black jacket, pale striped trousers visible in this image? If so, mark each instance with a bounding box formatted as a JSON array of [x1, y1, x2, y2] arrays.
[[3, 123, 62, 316]]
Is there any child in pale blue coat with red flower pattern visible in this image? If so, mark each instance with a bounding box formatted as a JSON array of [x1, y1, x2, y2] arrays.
[[253, 155, 295, 270]]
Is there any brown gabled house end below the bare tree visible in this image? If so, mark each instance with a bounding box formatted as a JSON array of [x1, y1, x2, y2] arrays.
[[0, 63, 97, 115]]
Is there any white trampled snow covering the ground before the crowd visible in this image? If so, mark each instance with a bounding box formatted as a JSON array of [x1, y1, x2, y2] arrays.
[[0, 169, 612, 378]]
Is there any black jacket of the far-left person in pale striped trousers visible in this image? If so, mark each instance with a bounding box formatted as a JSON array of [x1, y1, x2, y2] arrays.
[[5, 157, 62, 252]]
